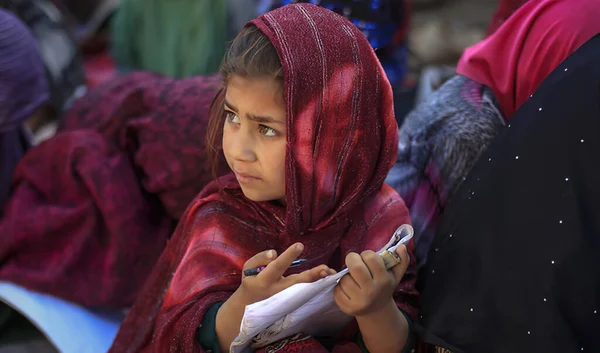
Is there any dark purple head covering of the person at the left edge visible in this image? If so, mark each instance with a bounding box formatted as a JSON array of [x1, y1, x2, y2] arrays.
[[0, 10, 48, 212]]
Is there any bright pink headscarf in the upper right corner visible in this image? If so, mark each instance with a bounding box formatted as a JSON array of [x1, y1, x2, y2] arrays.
[[456, 0, 600, 120]]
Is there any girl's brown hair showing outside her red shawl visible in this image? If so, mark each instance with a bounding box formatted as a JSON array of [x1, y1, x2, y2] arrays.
[[206, 26, 283, 178]]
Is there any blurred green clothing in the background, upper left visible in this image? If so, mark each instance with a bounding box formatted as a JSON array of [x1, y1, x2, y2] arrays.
[[112, 0, 229, 78]]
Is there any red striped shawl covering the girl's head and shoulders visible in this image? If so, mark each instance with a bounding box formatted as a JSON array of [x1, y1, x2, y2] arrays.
[[111, 4, 418, 352]]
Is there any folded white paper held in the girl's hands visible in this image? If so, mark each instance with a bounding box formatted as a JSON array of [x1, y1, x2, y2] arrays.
[[229, 225, 414, 353]]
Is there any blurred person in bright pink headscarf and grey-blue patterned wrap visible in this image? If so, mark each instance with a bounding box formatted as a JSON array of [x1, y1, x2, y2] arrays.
[[387, 0, 600, 267]]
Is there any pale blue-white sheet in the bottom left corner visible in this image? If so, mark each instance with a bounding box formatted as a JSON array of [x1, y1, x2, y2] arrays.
[[0, 281, 125, 353]]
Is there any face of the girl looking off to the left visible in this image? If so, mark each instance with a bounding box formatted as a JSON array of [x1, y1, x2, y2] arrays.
[[223, 75, 286, 204]]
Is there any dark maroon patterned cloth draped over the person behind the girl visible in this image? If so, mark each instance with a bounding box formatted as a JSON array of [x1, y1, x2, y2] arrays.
[[0, 73, 221, 308]]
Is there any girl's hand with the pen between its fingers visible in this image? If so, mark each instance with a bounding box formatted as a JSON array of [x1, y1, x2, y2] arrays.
[[235, 243, 335, 305]]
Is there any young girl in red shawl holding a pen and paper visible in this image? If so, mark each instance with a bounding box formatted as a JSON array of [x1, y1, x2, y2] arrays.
[[112, 4, 418, 353]]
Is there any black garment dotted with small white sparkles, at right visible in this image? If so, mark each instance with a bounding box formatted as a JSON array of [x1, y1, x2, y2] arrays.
[[417, 33, 600, 353]]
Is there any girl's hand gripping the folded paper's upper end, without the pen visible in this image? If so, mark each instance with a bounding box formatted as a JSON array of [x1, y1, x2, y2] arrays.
[[334, 245, 409, 317]]
